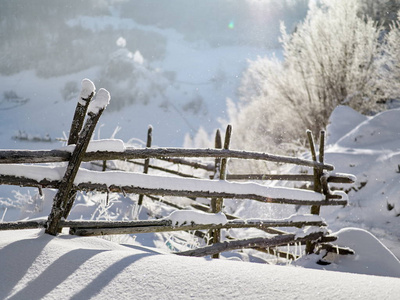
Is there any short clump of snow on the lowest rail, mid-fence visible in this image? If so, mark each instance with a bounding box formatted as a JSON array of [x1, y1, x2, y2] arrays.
[[165, 210, 228, 226]]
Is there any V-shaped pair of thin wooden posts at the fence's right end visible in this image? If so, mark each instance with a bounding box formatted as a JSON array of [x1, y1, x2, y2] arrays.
[[306, 130, 325, 254]]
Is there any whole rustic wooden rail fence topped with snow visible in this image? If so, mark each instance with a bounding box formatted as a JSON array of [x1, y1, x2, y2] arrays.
[[0, 79, 354, 258]]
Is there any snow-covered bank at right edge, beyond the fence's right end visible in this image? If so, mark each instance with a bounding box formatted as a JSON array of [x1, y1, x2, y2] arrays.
[[321, 107, 400, 257]]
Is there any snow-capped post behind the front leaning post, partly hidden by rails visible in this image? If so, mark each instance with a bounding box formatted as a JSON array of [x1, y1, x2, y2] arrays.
[[63, 78, 96, 218]]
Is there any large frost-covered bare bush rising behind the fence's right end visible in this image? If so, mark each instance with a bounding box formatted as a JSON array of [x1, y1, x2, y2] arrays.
[[231, 0, 386, 157]]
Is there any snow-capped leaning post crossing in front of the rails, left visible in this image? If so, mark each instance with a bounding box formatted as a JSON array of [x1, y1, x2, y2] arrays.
[[46, 89, 110, 235]]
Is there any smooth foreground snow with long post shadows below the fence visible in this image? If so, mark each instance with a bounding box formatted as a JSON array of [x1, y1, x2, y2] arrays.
[[0, 230, 400, 300]]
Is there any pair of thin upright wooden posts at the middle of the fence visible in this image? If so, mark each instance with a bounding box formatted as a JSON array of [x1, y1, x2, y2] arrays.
[[211, 125, 232, 258]]
